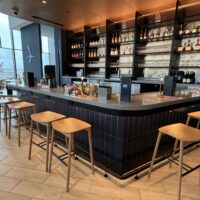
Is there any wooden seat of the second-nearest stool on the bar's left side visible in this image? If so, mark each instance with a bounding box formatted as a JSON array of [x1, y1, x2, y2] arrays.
[[31, 111, 65, 124]]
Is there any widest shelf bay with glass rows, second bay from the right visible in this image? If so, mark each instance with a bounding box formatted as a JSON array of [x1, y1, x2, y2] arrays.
[[134, 8, 174, 79]]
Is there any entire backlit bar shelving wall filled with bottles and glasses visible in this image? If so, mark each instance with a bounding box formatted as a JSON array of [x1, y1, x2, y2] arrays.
[[63, 0, 200, 83]]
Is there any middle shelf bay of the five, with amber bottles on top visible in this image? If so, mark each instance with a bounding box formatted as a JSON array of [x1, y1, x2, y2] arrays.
[[106, 19, 135, 79]]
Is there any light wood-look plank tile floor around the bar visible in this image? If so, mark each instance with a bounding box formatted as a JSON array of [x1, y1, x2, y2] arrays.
[[0, 122, 200, 200]]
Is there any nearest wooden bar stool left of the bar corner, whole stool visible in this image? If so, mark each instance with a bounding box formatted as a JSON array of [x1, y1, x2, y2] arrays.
[[49, 118, 94, 192]]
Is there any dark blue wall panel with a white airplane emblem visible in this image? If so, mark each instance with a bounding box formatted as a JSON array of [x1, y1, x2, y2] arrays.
[[21, 24, 42, 79]]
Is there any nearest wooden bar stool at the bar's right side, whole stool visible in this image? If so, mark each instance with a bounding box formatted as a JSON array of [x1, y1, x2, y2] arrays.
[[148, 123, 200, 200]]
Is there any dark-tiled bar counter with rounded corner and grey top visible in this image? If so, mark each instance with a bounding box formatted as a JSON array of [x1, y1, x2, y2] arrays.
[[7, 83, 200, 179]]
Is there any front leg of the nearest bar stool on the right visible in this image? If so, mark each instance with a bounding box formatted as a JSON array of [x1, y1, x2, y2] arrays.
[[177, 141, 183, 200]]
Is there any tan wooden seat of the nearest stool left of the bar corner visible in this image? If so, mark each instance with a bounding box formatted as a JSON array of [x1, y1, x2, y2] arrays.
[[52, 118, 91, 134]]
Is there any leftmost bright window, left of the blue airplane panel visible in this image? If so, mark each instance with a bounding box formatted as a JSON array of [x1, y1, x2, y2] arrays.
[[0, 13, 24, 79]]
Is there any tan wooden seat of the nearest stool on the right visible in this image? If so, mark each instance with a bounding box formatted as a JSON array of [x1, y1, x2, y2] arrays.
[[159, 123, 200, 142]]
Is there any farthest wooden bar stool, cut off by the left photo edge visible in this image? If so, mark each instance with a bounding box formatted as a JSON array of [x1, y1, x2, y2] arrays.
[[0, 96, 20, 135]]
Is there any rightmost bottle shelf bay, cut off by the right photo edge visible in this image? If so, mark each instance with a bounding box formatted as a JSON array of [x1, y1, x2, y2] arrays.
[[171, 0, 200, 82]]
